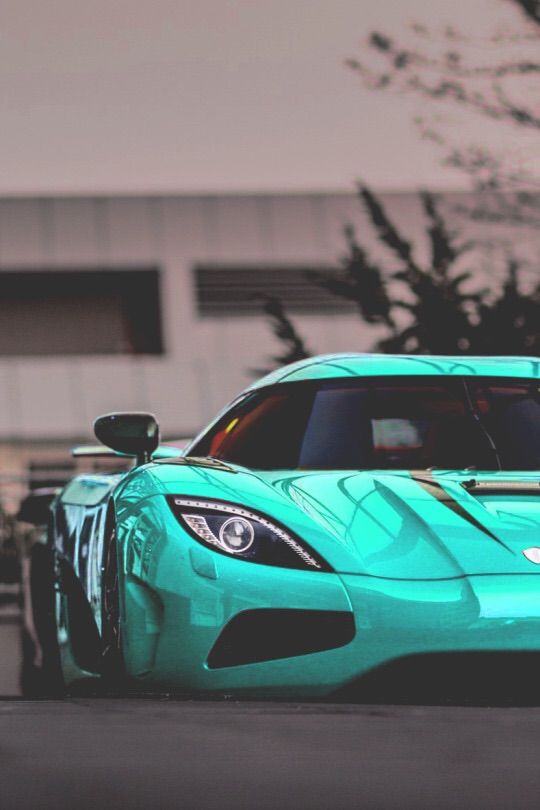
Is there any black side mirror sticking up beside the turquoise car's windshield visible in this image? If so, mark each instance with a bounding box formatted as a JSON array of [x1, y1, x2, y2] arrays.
[[94, 413, 159, 464]]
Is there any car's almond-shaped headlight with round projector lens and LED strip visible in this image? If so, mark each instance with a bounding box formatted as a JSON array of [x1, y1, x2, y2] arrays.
[[167, 497, 332, 571]]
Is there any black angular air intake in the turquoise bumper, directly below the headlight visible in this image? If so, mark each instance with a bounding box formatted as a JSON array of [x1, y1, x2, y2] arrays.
[[208, 609, 355, 669]]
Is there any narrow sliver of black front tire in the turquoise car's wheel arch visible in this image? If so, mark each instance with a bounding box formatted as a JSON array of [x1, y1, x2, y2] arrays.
[[101, 521, 126, 690]]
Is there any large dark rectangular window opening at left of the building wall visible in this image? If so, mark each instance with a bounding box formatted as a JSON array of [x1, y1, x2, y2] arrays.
[[0, 268, 163, 356]]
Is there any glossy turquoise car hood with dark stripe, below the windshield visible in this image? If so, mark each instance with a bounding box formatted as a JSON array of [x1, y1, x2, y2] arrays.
[[141, 465, 540, 579]]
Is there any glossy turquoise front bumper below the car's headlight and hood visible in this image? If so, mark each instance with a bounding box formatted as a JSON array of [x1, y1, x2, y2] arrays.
[[120, 492, 540, 698]]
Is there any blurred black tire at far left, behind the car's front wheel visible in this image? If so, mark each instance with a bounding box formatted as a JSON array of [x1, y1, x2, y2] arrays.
[[20, 543, 66, 698]]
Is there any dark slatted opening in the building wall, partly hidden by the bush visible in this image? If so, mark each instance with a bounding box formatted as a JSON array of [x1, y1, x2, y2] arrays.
[[194, 265, 355, 317]]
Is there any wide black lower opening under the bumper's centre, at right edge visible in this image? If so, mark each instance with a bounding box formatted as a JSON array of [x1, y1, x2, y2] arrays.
[[332, 651, 540, 706]]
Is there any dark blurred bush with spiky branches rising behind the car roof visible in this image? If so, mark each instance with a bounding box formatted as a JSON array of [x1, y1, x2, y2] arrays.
[[265, 185, 540, 365]]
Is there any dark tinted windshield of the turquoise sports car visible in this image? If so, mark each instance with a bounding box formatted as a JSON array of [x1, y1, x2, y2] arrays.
[[189, 377, 540, 470]]
